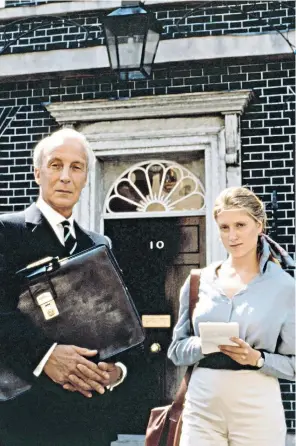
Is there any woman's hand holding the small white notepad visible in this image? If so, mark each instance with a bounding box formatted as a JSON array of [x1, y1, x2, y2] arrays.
[[219, 337, 261, 366]]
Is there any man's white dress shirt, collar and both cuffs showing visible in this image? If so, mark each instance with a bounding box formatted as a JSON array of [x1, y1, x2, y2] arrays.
[[33, 197, 127, 390]]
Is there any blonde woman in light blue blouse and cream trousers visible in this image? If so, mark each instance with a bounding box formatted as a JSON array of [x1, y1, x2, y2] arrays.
[[168, 187, 295, 446]]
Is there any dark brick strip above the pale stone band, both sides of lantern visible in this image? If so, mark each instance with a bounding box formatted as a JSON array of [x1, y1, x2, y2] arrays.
[[0, 1, 295, 53]]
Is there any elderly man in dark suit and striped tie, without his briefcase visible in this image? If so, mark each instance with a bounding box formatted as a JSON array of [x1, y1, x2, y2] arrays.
[[0, 129, 126, 446]]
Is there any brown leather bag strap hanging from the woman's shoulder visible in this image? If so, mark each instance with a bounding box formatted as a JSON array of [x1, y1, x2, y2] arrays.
[[170, 269, 200, 421]]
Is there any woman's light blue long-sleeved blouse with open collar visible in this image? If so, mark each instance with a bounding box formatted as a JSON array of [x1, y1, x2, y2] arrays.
[[168, 241, 295, 380]]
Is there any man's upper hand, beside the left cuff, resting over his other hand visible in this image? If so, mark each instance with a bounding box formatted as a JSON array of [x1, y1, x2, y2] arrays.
[[43, 345, 108, 398]]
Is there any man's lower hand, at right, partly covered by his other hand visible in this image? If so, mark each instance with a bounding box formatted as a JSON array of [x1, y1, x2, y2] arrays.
[[63, 362, 122, 393]]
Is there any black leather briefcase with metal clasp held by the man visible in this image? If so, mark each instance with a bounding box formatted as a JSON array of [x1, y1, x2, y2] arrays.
[[0, 244, 145, 401]]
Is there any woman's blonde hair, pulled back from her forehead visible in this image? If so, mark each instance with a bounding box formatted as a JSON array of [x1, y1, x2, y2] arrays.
[[214, 187, 267, 232]]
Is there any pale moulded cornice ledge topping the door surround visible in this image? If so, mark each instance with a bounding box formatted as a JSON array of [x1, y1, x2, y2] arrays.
[[46, 90, 253, 125]]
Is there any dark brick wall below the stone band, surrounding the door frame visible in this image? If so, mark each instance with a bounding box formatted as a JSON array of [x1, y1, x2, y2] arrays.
[[0, 60, 295, 253]]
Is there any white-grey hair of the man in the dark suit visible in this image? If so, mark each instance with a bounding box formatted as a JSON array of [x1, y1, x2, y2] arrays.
[[33, 128, 96, 170]]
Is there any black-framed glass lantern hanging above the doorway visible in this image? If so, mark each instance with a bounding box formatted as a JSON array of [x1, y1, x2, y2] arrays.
[[103, 1, 162, 80]]
